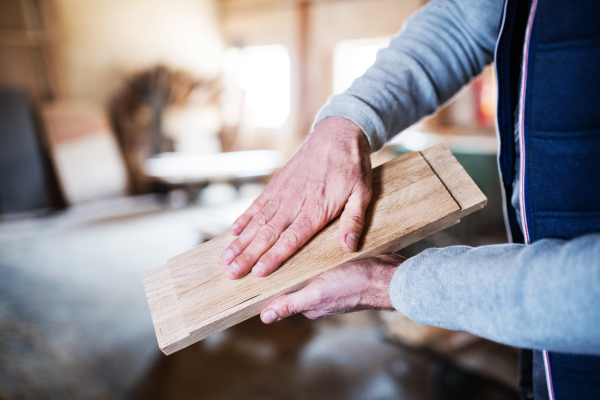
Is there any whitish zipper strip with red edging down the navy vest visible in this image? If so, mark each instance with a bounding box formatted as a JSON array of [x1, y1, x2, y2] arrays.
[[519, 0, 555, 400]]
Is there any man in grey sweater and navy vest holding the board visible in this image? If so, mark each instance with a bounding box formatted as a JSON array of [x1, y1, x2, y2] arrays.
[[222, 0, 600, 400]]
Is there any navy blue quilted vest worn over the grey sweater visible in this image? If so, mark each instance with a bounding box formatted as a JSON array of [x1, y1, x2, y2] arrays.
[[496, 0, 600, 400]]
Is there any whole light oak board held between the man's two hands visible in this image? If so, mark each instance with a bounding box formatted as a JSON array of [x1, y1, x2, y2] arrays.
[[143, 144, 486, 354]]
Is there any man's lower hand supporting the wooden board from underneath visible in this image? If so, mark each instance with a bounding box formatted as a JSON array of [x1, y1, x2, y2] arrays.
[[260, 254, 405, 324]]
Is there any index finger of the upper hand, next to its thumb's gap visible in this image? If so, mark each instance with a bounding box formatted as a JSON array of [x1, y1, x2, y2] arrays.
[[252, 213, 321, 276]]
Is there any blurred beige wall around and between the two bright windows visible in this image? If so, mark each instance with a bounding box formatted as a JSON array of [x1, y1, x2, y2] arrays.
[[221, 0, 425, 146]]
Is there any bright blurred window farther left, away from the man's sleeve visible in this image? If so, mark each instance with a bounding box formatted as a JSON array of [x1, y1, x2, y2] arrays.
[[224, 45, 290, 129]]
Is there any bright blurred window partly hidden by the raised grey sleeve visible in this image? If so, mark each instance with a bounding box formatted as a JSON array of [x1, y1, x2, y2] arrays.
[[333, 37, 390, 93]]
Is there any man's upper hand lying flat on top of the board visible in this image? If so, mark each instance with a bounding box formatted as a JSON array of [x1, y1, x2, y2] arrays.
[[221, 117, 371, 279]]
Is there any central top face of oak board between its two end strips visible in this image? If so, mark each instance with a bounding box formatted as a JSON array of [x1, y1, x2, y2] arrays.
[[167, 153, 459, 331]]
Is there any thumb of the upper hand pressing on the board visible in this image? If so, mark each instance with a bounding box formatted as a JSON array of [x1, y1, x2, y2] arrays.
[[339, 189, 371, 253]]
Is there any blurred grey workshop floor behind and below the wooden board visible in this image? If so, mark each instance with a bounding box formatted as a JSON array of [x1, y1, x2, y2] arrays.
[[0, 198, 515, 400]]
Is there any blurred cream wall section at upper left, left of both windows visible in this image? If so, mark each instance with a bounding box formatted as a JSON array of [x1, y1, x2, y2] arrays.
[[56, 0, 222, 102]]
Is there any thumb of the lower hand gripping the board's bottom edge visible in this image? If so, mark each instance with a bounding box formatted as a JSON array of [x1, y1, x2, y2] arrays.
[[260, 286, 319, 324]]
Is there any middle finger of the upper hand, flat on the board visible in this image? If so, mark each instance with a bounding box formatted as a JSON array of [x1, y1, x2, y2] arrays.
[[225, 213, 291, 279]]
